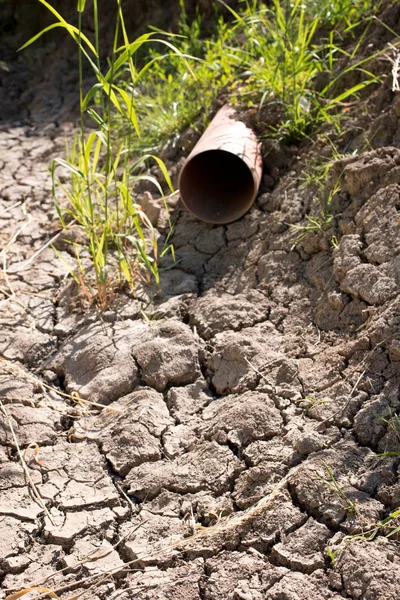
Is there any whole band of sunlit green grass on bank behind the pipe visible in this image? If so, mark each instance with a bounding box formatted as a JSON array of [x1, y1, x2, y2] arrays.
[[126, 0, 378, 149]]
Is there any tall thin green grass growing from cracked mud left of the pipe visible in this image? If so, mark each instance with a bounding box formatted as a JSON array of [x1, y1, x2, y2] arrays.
[[22, 0, 182, 308]]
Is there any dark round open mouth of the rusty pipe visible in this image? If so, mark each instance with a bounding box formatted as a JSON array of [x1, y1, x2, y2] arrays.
[[179, 150, 254, 224]]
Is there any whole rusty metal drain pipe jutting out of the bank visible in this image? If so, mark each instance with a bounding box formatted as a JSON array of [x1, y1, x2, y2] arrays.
[[179, 106, 262, 225]]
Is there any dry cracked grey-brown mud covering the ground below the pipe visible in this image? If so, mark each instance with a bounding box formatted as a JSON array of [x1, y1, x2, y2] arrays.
[[0, 4, 400, 600]]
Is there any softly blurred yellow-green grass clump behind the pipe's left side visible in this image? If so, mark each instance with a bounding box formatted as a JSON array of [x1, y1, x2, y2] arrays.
[[117, 0, 240, 152]]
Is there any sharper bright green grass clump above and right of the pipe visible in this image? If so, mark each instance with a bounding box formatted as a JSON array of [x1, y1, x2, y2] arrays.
[[223, 0, 378, 140]]
